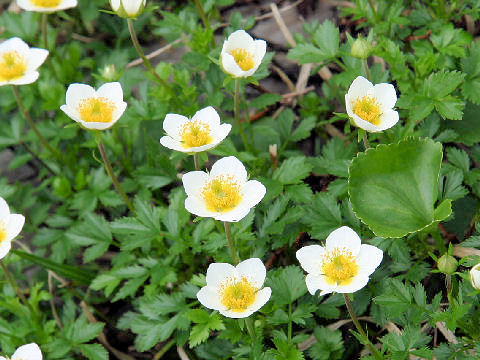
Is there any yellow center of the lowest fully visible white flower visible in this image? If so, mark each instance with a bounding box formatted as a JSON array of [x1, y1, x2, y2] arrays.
[[220, 277, 258, 312]]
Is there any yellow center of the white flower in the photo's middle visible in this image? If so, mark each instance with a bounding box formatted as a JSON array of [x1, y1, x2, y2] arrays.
[[202, 175, 242, 212]]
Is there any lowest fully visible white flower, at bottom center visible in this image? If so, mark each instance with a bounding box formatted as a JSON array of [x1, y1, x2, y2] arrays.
[[197, 258, 272, 319]]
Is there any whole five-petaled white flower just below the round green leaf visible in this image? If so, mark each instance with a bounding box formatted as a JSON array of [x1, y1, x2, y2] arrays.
[[297, 226, 383, 295]]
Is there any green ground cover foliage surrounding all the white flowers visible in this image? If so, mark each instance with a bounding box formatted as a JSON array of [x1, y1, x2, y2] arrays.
[[0, 0, 480, 360]]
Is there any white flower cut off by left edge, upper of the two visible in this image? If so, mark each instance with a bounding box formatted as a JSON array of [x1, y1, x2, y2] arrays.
[[0, 37, 48, 86]]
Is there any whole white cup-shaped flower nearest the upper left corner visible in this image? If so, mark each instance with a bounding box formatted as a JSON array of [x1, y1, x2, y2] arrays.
[[60, 82, 127, 130]]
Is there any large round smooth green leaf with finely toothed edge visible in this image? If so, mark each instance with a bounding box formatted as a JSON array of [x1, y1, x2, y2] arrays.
[[348, 138, 451, 237]]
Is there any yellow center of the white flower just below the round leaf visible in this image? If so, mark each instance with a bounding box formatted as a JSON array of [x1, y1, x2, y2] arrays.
[[322, 248, 359, 285]]
